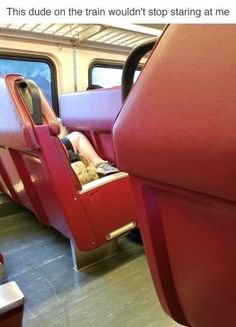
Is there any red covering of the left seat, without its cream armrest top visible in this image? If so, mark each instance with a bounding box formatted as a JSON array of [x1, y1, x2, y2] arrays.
[[0, 75, 135, 250]]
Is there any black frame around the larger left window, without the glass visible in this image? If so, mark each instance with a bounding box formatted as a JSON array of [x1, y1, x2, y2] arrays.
[[0, 51, 59, 116]]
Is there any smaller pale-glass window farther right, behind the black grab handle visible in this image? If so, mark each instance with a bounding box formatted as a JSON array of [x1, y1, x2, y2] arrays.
[[89, 63, 141, 87]]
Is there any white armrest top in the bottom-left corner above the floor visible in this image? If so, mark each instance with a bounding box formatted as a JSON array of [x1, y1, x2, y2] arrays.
[[0, 282, 24, 315]]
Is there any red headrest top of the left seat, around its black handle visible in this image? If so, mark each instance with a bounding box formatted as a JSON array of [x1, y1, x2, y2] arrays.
[[0, 74, 60, 150]]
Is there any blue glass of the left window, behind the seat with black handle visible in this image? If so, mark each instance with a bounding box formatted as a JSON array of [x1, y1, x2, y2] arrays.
[[0, 58, 52, 105]]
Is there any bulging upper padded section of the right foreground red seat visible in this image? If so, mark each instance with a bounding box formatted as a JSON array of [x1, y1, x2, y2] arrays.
[[113, 24, 236, 200]]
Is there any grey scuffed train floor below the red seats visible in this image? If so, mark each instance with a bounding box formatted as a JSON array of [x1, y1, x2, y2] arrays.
[[0, 201, 183, 327]]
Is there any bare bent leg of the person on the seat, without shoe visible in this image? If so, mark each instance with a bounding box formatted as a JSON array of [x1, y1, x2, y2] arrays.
[[66, 132, 104, 164]]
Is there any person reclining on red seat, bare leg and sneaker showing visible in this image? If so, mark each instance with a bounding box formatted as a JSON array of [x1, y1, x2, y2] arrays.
[[58, 118, 119, 176]]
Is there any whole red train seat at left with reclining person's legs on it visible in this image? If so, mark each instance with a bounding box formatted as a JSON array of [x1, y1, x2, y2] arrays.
[[0, 74, 136, 267]]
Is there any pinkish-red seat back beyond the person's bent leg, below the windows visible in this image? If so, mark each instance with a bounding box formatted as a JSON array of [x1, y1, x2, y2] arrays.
[[60, 87, 121, 162]]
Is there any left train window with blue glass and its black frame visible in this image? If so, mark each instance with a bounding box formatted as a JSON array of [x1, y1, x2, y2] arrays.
[[0, 55, 58, 113]]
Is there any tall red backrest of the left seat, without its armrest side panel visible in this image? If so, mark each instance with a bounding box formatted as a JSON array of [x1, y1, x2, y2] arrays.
[[0, 75, 97, 248]]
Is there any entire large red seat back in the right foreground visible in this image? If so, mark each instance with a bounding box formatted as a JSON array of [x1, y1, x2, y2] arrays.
[[113, 25, 236, 327]]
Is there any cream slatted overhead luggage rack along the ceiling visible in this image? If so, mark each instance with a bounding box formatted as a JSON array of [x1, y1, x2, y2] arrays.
[[0, 23, 164, 49]]
